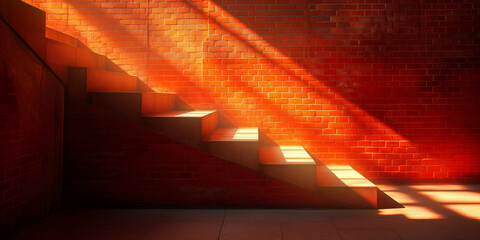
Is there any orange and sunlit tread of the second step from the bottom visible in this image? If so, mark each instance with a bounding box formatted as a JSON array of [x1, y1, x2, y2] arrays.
[[259, 146, 316, 165]]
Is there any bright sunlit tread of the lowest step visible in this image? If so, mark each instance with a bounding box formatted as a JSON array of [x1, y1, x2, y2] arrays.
[[326, 165, 376, 187]]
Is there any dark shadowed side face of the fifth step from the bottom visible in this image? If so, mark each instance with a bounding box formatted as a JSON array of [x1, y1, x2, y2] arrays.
[[88, 92, 144, 123]]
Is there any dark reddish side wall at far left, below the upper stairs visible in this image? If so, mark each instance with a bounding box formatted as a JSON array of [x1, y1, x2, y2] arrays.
[[0, 20, 64, 236]]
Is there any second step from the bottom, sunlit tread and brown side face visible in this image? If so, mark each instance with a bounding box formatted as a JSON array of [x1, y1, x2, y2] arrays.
[[259, 146, 317, 191]]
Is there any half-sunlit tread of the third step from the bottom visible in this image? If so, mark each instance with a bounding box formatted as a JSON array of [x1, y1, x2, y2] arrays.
[[204, 128, 258, 142]]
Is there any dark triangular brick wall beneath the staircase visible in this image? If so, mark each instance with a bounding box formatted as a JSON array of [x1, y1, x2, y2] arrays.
[[64, 105, 335, 208]]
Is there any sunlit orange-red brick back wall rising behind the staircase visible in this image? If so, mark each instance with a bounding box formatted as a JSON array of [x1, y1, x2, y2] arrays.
[[27, 0, 480, 181]]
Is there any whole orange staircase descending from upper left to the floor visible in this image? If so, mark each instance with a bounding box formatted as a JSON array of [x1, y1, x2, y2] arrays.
[[0, 0, 378, 208]]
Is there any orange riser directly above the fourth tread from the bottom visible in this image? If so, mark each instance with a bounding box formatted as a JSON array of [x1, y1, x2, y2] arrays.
[[142, 92, 177, 116]]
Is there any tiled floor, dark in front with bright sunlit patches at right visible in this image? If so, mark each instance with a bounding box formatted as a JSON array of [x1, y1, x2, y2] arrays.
[[9, 185, 480, 240]]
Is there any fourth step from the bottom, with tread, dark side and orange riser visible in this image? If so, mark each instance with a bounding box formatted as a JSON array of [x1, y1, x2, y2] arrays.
[[144, 110, 218, 148]]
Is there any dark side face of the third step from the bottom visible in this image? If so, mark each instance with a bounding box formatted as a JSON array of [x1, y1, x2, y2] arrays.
[[203, 141, 259, 171]]
